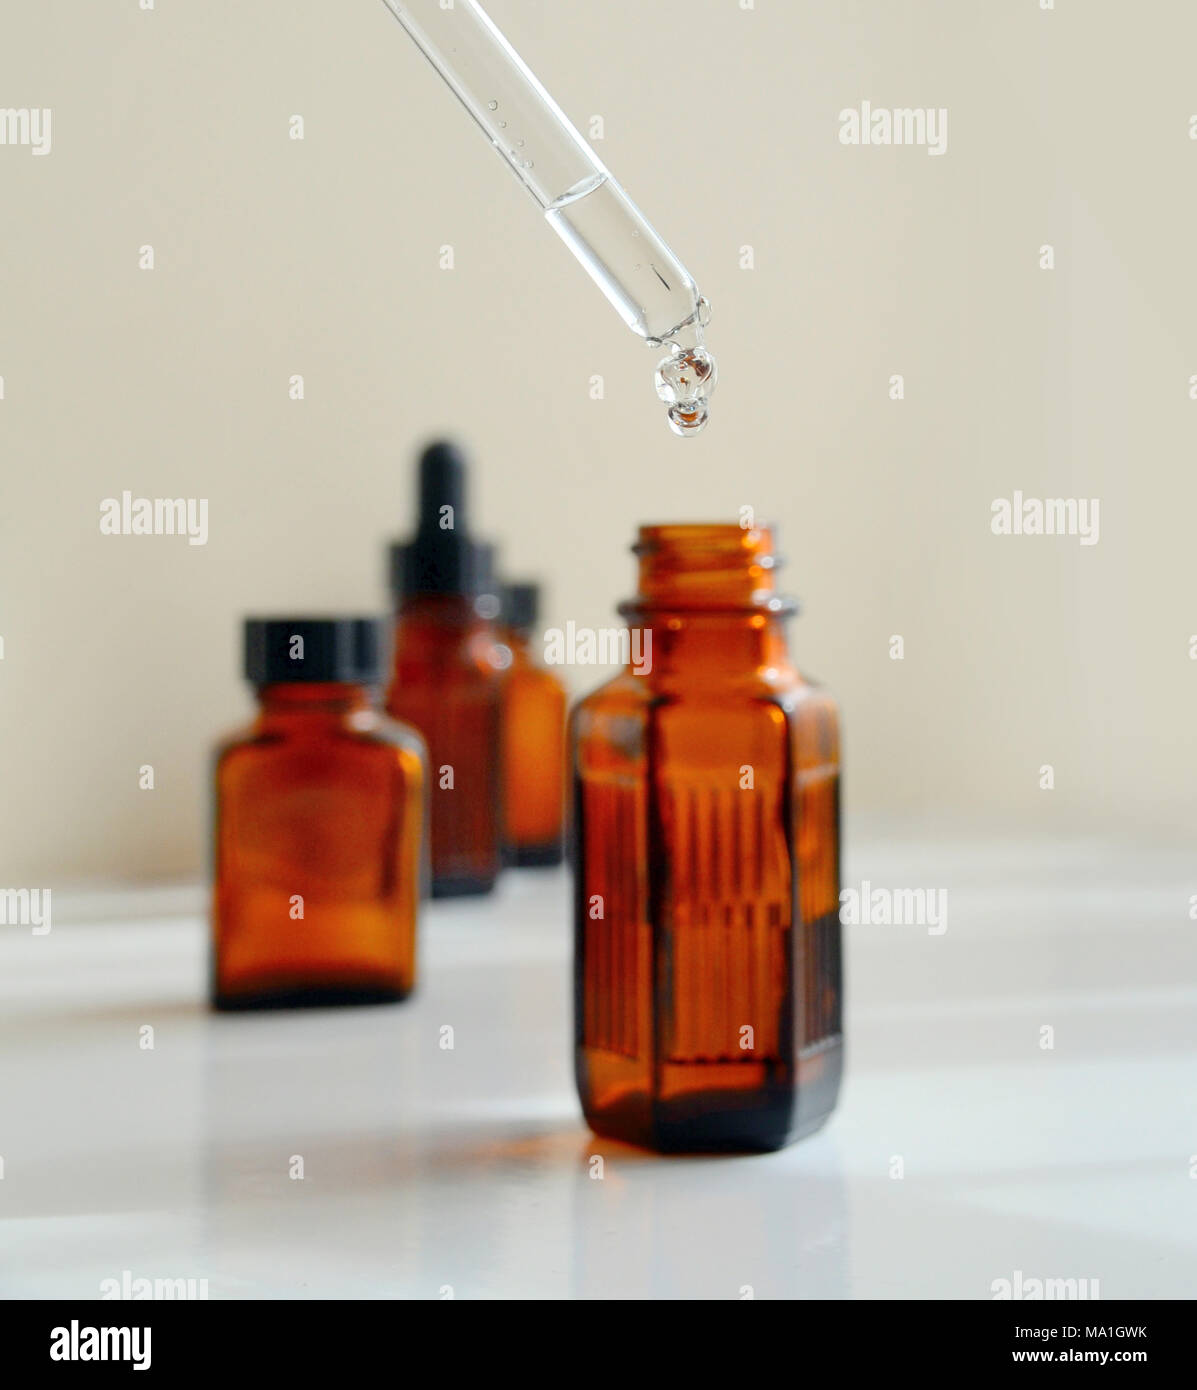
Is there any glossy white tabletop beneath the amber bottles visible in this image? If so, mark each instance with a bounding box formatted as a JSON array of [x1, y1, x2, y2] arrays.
[[0, 834, 1197, 1298]]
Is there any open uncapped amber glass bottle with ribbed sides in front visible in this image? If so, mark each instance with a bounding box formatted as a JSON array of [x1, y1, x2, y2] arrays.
[[570, 525, 842, 1151]]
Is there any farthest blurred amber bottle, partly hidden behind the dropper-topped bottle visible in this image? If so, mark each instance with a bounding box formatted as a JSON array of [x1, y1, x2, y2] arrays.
[[499, 584, 566, 867]]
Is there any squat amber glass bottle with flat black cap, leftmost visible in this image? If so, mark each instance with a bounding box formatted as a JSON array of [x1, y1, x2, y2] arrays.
[[211, 619, 425, 1009]]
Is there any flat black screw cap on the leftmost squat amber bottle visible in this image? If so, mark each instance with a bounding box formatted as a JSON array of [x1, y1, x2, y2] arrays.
[[245, 617, 382, 685]]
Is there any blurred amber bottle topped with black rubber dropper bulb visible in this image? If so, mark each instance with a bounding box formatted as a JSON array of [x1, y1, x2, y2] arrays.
[[386, 443, 507, 898]]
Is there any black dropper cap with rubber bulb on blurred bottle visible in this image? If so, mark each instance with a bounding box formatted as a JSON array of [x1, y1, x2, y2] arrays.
[[391, 441, 494, 598]]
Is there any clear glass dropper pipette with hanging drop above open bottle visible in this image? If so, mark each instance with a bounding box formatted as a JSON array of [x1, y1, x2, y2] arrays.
[[382, 0, 716, 435]]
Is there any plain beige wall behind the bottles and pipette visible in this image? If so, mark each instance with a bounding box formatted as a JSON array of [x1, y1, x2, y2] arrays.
[[0, 0, 1197, 884]]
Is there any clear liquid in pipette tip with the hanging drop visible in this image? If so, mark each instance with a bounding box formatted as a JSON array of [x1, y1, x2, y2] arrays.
[[545, 174, 717, 436]]
